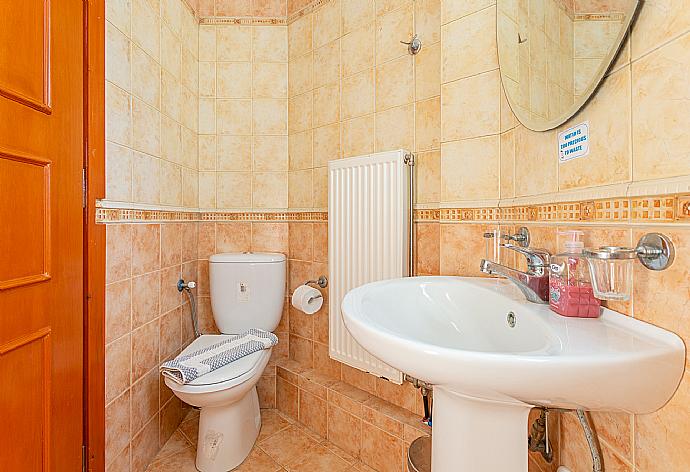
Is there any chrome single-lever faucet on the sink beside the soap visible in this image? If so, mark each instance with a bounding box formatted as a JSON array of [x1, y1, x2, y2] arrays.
[[479, 244, 551, 303]]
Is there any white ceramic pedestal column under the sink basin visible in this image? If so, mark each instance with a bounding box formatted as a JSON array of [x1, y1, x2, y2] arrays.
[[431, 386, 531, 472]]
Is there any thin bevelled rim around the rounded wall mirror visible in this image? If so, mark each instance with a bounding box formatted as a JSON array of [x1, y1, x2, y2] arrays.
[[496, 0, 644, 131]]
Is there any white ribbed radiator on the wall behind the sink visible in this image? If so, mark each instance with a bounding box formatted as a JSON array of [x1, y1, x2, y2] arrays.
[[328, 150, 411, 384]]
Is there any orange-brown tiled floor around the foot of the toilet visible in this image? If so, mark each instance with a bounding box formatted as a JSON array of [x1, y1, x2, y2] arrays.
[[147, 410, 375, 472]]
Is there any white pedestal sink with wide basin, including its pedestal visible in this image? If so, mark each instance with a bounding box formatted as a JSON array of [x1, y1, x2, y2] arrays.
[[342, 277, 685, 472]]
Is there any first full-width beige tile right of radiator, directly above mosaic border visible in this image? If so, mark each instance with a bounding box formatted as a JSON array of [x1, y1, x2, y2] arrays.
[[441, 136, 500, 202]]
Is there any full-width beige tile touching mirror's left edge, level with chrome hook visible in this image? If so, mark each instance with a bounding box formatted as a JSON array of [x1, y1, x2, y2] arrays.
[[441, 7, 498, 83]]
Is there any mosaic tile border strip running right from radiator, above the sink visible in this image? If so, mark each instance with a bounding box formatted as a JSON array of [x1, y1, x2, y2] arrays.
[[414, 194, 690, 224]]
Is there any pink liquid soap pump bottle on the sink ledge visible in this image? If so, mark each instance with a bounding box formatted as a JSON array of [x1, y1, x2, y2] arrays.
[[549, 230, 601, 318]]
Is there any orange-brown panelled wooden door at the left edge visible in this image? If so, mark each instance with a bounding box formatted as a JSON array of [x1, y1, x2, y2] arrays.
[[0, 0, 84, 472]]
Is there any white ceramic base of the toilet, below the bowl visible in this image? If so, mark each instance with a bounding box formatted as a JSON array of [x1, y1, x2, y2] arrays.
[[196, 387, 261, 472]]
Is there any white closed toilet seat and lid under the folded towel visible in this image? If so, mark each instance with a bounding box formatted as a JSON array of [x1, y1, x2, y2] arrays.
[[165, 334, 271, 393]]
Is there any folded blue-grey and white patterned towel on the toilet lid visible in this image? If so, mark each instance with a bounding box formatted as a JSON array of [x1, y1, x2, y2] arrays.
[[160, 329, 278, 385]]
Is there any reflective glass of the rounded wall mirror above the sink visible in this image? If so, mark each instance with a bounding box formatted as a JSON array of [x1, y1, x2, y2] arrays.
[[496, 0, 639, 131]]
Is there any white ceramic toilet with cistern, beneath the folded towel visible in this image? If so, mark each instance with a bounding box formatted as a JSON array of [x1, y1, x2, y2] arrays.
[[165, 253, 286, 472]]
